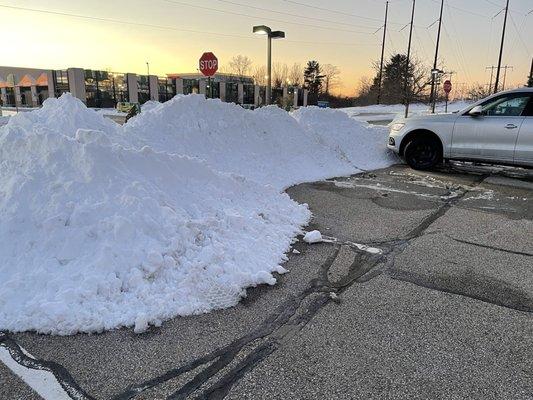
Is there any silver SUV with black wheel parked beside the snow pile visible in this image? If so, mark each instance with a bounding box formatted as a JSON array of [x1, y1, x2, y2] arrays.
[[388, 88, 533, 169]]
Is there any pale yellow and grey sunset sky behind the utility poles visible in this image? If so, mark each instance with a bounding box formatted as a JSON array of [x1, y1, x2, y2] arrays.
[[0, 0, 533, 94]]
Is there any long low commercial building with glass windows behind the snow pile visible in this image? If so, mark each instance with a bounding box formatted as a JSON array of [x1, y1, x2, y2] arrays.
[[0, 67, 307, 108]]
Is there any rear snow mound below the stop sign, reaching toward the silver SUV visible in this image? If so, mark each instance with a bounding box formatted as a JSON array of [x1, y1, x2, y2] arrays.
[[124, 95, 387, 190]]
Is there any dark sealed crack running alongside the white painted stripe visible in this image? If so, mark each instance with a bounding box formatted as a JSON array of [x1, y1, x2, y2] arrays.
[[0, 332, 95, 400]]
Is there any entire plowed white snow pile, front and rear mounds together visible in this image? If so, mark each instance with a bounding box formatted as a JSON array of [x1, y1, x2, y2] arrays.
[[0, 94, 394, 335]]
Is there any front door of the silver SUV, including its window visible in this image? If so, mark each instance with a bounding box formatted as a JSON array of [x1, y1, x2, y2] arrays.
[[451, 92, 530, 163]]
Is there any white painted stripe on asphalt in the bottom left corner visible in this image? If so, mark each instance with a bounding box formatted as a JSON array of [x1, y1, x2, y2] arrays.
[[0, 345, 72, 400]]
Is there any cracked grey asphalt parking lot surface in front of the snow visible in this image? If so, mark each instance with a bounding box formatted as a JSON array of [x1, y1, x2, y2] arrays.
[[0, 164, 533, 399]]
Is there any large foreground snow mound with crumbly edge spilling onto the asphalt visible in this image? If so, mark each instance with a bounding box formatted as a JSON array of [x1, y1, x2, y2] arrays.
[[0, 97, 309, 334]]
